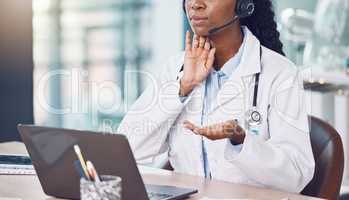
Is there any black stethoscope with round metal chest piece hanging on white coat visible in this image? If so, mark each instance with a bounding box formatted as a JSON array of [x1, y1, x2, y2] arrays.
[[177, 45, 262, 128]]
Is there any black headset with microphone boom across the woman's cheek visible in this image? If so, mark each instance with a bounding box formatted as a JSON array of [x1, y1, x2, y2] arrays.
[[183, 0, 255, 35]]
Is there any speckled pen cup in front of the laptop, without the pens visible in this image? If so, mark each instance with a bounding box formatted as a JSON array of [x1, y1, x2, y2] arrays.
[[80, 176, 122, 200]]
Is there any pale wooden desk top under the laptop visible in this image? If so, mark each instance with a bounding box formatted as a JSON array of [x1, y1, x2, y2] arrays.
[[0, 142, 316, 200]]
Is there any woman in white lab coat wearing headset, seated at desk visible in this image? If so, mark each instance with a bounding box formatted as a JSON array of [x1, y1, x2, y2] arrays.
[[118, 0, 314, 192]]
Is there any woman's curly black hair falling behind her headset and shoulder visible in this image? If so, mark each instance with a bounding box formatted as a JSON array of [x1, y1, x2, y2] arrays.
[[183, 0, 285, 56]]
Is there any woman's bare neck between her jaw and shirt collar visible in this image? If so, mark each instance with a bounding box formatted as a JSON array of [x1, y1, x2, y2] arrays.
[[210, 23, 243, 70]]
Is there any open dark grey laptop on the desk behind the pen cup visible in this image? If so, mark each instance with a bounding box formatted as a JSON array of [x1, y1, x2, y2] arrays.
[[18, 125, 197, 200]]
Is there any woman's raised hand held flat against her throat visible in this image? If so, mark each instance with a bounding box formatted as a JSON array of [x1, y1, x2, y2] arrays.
[[179, 31, 216, 96]]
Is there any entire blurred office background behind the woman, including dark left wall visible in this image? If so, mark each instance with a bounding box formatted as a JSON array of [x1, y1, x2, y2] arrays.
[[0, 0, 349, 194]]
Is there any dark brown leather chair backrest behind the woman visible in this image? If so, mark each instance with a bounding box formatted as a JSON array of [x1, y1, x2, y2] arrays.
[[302, 116, 344, 199]]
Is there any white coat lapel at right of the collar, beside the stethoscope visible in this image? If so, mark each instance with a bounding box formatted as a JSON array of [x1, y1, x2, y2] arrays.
[[209, 27, 261, 113]]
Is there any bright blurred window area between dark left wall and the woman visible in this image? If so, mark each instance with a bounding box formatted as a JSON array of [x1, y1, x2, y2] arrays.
[[33, 0, 183, 131]]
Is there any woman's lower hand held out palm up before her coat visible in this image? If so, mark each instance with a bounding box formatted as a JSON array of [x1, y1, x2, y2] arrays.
[[183, 120, 246, 145]]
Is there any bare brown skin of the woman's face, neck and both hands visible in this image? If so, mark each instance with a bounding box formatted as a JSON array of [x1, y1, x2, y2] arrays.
[[179, 0, 245, 144]]
